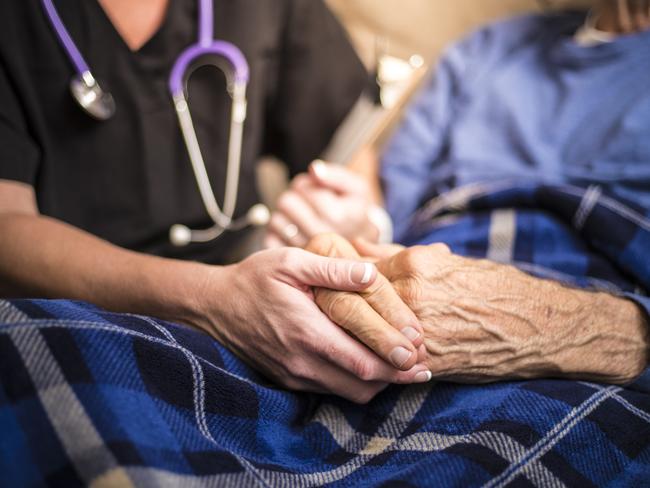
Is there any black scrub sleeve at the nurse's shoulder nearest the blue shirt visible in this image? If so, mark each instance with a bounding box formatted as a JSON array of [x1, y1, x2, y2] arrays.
[[265, 0, 368, 175]]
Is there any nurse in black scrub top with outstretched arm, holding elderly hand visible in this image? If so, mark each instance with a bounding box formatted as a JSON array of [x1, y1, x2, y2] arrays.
[[0, 0, 425, 401]]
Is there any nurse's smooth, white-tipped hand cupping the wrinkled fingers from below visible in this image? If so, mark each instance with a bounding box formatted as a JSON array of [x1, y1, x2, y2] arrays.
[[196, 248, 425, 403]]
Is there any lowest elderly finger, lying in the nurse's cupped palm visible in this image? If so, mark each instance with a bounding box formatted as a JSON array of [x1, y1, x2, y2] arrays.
[[314, 288, 421, 371]]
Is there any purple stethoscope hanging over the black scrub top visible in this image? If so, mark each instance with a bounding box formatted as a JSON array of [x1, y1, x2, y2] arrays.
[[42, 0, 270, 246]]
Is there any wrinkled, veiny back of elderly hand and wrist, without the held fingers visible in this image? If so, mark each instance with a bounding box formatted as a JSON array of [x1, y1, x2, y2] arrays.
[[357, 243, 649, 383]]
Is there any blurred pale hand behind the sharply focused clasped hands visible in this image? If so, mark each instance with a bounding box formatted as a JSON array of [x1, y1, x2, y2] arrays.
[[264, 161, 379, 248]]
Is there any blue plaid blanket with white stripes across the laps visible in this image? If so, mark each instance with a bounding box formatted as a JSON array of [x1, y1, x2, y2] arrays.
[[0, 182, 650, 487]]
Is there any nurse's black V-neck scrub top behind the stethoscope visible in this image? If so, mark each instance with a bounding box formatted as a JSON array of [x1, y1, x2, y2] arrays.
[[0, 0, 366, 263]]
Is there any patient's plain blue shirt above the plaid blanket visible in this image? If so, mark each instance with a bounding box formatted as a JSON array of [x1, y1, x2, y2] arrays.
[[382, 13, 650, 240]]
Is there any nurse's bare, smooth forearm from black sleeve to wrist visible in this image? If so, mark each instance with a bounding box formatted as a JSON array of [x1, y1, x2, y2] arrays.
[[0, 214, 207, 320]]
